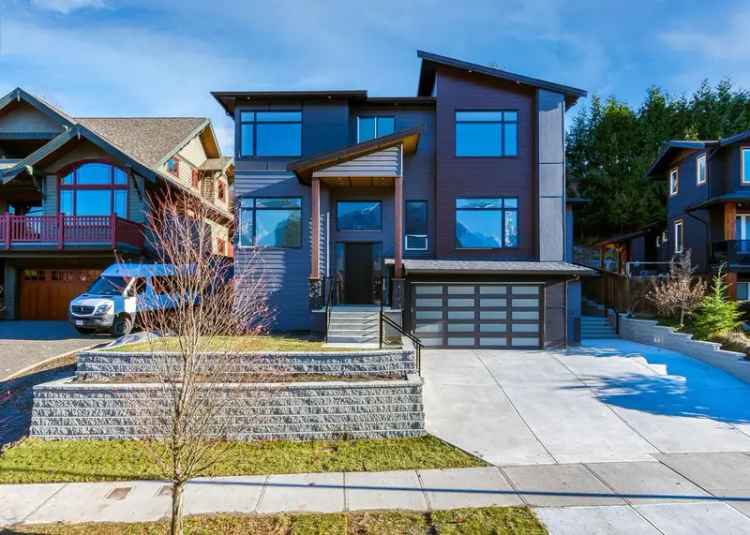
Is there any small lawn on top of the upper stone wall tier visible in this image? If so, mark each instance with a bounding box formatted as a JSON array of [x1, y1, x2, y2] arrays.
[[108, 333, 364, 351]]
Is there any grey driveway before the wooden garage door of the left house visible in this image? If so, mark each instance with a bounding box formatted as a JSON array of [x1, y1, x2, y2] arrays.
[[0, 321, 112, 381]]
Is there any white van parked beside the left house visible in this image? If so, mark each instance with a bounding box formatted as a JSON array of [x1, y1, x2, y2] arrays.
[[69, 264, 175, 337]]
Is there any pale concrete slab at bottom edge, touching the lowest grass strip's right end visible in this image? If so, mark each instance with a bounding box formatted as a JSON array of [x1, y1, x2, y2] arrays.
[[534, 505, 662, 535]]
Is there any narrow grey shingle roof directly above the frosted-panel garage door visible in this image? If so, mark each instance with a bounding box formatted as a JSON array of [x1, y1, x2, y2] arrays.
[[388, 258, 594, 275]]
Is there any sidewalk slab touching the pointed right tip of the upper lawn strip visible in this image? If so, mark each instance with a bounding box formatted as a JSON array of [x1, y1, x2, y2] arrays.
[[418, 467, 523, 509]]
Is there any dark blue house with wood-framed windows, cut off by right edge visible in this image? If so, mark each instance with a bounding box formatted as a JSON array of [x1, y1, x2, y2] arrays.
[[647, 131, 750, 301]]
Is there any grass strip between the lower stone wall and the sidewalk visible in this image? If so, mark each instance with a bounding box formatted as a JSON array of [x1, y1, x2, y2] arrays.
[[0, 436, 485, 483]]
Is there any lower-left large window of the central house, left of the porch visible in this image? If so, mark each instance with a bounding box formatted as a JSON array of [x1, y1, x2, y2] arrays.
[[239, 197, 302, 248]]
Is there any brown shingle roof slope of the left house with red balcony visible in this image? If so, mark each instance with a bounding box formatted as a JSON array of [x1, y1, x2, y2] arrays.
[[76, 117, 208, 168]]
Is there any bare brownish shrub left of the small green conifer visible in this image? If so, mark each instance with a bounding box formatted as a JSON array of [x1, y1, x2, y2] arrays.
[[648, 250, 706, 327]]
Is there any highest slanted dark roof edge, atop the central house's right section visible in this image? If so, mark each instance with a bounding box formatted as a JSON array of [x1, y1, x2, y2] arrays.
[[417, 50, 587, 108]]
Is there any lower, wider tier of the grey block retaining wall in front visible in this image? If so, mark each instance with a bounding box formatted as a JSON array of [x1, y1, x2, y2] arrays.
[[31, 375, 424, 440]]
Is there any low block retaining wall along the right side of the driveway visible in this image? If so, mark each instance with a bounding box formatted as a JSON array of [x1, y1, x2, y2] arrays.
[[610, 315, 750, 383]]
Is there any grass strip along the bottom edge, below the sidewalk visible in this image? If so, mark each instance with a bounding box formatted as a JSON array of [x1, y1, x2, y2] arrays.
[[7, 507, 547, 535]]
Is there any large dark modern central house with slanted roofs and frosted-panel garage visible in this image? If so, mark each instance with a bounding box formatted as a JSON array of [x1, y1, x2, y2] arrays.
[[213, 51, 589, 348]]
